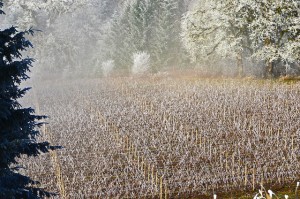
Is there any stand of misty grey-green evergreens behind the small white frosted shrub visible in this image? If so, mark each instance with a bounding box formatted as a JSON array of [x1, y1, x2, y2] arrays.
[[107, 0, 183, 71]]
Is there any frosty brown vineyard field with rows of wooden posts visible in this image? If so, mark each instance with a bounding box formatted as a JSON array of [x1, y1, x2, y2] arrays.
[[20, 78, 300, 198]]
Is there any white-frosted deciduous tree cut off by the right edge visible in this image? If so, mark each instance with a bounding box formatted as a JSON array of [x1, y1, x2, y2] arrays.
[[247, 0, 300, 75]]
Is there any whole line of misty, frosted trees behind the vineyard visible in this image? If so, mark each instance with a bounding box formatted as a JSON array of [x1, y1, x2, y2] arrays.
[[2, 0, 300, 77]]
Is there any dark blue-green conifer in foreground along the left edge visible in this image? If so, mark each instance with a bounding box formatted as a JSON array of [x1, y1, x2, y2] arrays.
[[0, 0, 54, 199]]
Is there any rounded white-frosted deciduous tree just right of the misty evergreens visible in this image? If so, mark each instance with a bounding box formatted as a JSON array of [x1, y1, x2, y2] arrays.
[[182, 0, 252, 75]]
